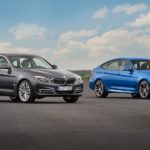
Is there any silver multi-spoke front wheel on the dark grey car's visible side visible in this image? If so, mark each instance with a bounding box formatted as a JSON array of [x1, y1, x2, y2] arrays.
[[18, 80, 35, 103]]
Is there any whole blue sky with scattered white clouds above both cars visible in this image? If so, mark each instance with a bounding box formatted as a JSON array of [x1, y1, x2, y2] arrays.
[[0, 0, 150, 70]]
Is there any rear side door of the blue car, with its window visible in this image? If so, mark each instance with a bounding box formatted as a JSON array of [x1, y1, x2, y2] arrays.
[[101, 59, 120, 91]]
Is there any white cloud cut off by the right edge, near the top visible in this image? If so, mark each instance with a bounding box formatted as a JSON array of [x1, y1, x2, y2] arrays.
[[127, 12, 150, 27]]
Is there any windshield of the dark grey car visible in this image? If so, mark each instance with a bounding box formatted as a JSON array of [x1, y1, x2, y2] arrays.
[[10, 56, 52, 69]]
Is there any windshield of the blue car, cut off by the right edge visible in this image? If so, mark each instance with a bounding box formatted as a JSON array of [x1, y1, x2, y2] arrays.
[[131, 60, 150, 70]]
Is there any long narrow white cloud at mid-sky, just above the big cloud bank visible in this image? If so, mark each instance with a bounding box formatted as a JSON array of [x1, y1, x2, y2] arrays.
[[59, 29, 96, 41]]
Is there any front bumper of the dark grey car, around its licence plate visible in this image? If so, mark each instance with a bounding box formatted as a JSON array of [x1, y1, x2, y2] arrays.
[[35, 83, 83, 97]]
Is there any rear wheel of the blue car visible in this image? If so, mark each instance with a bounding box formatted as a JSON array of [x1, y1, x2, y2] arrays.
[[94, 80, 108, 98]]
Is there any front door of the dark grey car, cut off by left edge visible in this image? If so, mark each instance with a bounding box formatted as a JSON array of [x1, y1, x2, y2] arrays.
[[0, 56, 15, 94]]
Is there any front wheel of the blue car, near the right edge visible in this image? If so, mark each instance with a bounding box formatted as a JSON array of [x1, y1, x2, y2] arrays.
[[139, 80, 150, 99]]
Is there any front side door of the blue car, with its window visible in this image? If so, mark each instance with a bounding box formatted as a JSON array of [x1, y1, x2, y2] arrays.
[[118, 59, 137, 92]]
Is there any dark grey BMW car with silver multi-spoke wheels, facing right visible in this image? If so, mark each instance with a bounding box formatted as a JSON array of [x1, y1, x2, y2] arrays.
[[0, 54, 83, 103]]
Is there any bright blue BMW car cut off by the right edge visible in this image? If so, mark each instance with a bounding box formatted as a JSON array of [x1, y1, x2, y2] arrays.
[[89, 58, 150, 99]]
